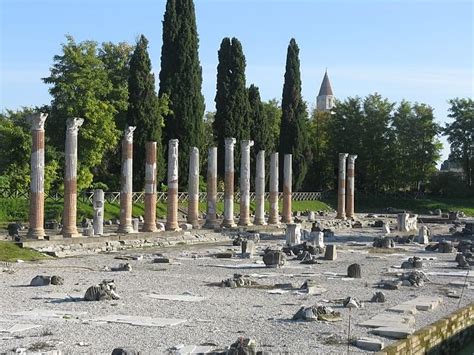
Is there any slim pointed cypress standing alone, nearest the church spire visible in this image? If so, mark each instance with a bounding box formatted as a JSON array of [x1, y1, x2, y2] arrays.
[[279, 38, 311, 191]]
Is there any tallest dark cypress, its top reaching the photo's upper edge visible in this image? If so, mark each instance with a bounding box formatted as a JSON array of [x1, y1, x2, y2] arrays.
[[159, 0, 204, 187]]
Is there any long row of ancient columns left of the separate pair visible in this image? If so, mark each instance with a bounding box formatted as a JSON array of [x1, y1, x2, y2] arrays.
[[28, 113, 292, 239]]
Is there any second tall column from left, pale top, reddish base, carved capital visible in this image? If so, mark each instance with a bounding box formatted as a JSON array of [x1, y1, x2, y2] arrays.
[[61, 117, 84, 238]]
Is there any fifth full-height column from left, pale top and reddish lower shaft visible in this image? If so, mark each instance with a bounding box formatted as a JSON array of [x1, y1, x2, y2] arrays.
[[165, 139, 179, 231]]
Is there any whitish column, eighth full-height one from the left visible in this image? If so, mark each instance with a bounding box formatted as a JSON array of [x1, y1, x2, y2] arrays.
[[222, 138, 235, 227]]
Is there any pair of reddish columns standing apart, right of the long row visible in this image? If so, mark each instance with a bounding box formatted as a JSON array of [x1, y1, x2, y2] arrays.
[[336, 153, 357, 219]]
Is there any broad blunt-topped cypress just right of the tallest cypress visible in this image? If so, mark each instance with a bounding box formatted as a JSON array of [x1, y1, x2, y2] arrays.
[[213, 37, 251, 177]]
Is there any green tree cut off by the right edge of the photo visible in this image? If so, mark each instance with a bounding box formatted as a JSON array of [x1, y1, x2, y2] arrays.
[[444, 98, 474, 187]]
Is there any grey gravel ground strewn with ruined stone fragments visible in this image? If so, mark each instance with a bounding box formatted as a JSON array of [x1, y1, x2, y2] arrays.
[[0, 218, 474, 354]]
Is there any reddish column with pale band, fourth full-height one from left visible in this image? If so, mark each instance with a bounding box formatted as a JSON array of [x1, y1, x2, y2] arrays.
[[143, 142, 158, 232]]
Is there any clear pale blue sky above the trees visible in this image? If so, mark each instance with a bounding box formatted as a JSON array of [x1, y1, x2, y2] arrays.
[[0, 0, 474, 161]]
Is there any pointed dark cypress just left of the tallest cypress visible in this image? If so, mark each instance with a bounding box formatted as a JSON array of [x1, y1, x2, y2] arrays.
[[127, 35, 164, 191]]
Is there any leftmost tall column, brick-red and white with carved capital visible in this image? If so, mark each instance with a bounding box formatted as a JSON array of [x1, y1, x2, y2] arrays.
[[28, 113, 48, 239]]
